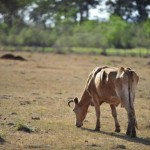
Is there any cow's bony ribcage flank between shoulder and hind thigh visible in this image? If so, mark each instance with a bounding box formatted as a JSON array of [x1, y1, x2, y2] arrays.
[[94, 67, 120, 105]]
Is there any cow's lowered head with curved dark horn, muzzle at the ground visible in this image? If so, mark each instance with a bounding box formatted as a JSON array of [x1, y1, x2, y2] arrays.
[[68, 97, 86, 127]]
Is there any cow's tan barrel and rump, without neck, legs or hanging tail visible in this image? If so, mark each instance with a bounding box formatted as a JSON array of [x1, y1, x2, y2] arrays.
[[94, 67, 138, 105]]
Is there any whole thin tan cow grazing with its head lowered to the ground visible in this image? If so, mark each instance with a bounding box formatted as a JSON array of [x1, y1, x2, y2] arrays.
[[68, 66, 139, 137]]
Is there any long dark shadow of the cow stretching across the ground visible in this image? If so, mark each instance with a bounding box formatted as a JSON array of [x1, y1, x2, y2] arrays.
[[81, 127, 150, 145]]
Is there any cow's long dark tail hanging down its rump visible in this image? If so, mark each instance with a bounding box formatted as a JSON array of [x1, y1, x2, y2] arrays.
[[127, 70, 138, 129]]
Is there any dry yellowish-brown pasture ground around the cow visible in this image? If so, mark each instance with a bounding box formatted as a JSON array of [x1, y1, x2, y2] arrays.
[[0, 51, 150, 150]]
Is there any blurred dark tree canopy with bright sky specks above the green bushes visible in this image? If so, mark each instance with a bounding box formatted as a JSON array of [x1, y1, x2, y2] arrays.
[[0, 0, 150, 26]]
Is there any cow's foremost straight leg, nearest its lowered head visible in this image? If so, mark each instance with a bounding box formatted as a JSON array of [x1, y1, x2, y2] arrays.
[[95, 104, 100, 131]]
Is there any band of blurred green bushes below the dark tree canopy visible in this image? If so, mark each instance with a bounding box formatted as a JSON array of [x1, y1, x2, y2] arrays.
[[0, 16, 150, 49]]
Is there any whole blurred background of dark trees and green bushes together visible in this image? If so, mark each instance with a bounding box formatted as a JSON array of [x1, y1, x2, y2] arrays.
[[0, 0, 150, 50]]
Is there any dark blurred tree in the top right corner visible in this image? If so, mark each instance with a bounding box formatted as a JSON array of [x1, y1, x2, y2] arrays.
[[106, 0, 150, 21]]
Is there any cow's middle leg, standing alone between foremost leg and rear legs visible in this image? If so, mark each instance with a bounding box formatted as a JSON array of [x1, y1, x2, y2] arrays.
[[110, 105, 120, 132]]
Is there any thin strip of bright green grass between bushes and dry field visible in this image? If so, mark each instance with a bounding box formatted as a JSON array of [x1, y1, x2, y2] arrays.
[[0, 46, 150, 57]]
